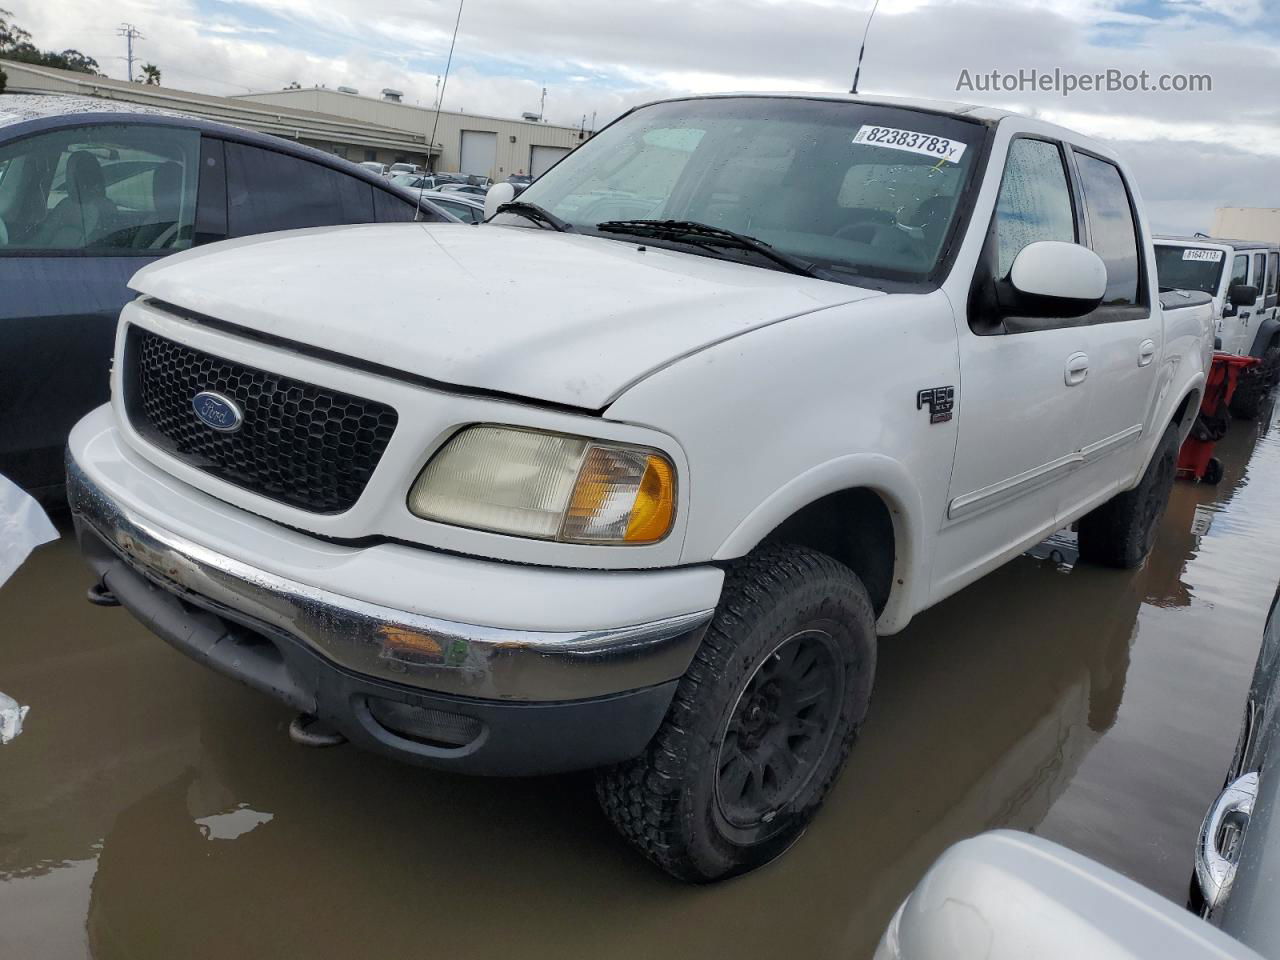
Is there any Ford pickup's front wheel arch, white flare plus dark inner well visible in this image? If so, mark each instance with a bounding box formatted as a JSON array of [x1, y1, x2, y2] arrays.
[[714, 454, 927, 634]]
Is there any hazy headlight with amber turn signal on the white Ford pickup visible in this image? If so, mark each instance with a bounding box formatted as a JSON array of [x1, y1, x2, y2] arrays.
[[408, 426, 676, 544]]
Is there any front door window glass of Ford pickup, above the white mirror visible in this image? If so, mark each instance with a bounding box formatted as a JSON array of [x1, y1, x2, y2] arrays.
[[996, 137, 1076, 279]]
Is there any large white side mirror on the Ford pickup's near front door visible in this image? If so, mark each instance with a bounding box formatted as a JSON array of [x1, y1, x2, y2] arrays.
[[1006, 241, 1107, 317]]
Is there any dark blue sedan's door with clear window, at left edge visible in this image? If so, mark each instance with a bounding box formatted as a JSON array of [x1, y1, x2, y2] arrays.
[[0, 123, 200, 494]]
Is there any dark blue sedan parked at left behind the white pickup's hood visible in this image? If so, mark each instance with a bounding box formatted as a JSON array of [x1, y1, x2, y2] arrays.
[[0, 95, 453, 503]]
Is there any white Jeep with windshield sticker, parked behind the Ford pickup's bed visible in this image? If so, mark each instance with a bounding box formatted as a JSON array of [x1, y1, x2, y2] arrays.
[[1155, 237, 1280, 420]]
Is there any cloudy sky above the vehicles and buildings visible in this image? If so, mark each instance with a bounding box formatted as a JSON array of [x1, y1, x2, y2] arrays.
[[10, 0, 1280, 230]]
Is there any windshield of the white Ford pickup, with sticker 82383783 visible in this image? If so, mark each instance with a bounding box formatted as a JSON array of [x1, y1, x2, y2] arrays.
[[512, 96, 986, 280]]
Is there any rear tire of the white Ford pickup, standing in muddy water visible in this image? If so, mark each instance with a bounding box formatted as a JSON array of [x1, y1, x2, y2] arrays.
[[1078, 424, 1178, 570]]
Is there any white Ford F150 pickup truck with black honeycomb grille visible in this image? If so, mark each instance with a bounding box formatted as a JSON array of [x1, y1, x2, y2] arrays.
[[68, 93, 1212, 881]]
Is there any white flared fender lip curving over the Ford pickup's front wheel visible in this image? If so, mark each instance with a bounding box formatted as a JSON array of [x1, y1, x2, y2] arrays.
[[714, 453, 929, 634]]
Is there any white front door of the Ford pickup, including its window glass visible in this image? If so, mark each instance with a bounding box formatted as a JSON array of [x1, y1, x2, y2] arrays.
[[933, 137, 1091, 599]]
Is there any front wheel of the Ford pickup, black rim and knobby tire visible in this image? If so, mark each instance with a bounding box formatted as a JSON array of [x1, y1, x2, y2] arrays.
[[596, 545, 876, 883]]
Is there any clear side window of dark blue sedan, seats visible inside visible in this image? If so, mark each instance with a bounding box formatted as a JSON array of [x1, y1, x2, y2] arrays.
[[0, 124, 200, 256]]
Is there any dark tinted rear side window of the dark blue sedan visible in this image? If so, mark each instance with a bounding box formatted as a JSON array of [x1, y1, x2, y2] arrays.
[[227, 142, 375, 237]]
